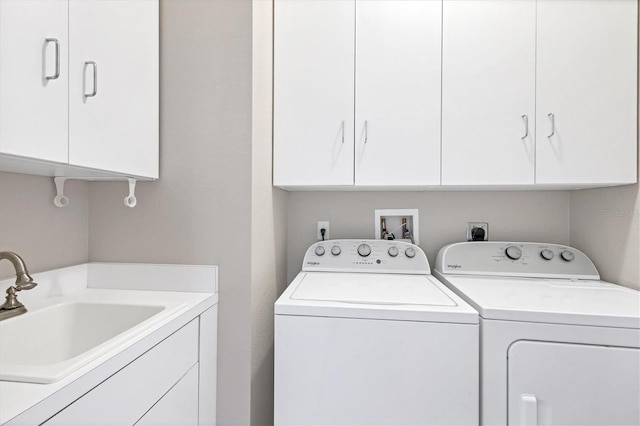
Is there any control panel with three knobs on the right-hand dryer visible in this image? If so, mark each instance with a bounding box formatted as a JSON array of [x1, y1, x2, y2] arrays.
[[435, 241, 600, 280]]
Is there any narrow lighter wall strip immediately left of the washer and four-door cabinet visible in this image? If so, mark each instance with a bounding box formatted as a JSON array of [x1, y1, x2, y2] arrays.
[[251, 0, 287, 425]]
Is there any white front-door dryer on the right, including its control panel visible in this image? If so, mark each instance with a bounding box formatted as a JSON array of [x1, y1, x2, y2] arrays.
[[434, 242, 640, 426]]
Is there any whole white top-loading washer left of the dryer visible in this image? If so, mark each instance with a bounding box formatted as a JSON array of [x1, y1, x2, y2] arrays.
[[274, 240, 479, 425]]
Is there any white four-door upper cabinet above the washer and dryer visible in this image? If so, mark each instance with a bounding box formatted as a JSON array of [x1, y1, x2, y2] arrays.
[[274, 0, 638, 189]]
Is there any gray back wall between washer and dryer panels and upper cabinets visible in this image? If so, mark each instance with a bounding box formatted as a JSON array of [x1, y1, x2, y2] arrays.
[[287, 191, 569, 280]]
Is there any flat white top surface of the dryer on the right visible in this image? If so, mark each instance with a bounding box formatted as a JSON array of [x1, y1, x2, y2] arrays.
[[442, 275, 640, 329]]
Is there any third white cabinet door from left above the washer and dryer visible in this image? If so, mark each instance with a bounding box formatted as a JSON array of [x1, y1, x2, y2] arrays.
[[442, 0, 536, 185]]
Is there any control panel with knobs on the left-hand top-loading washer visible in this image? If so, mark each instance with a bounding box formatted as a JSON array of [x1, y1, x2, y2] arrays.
[[302, 240, 431, 274]]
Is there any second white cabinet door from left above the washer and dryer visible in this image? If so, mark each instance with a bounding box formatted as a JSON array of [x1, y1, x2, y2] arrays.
[[355, 0, 442, 185]]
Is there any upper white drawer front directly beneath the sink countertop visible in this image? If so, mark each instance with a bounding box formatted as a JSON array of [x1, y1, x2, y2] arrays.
[[45, 319, 199, 426]]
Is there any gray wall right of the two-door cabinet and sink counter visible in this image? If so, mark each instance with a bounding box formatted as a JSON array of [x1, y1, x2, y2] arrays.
[[89, 0, 252, 425]]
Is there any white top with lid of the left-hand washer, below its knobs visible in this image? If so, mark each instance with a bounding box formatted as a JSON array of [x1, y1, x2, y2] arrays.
[[275, 272, 479, 324]]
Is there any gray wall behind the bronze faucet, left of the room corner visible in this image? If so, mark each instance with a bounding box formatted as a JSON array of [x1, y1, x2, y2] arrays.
[[0, 172, 87, 278]]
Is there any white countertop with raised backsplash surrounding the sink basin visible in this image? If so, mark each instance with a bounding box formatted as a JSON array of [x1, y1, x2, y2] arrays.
[[0, 264, 218, 425]]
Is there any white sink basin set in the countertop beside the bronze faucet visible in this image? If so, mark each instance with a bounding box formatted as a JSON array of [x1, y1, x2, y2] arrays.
[[0, 302, 165, 383]]
